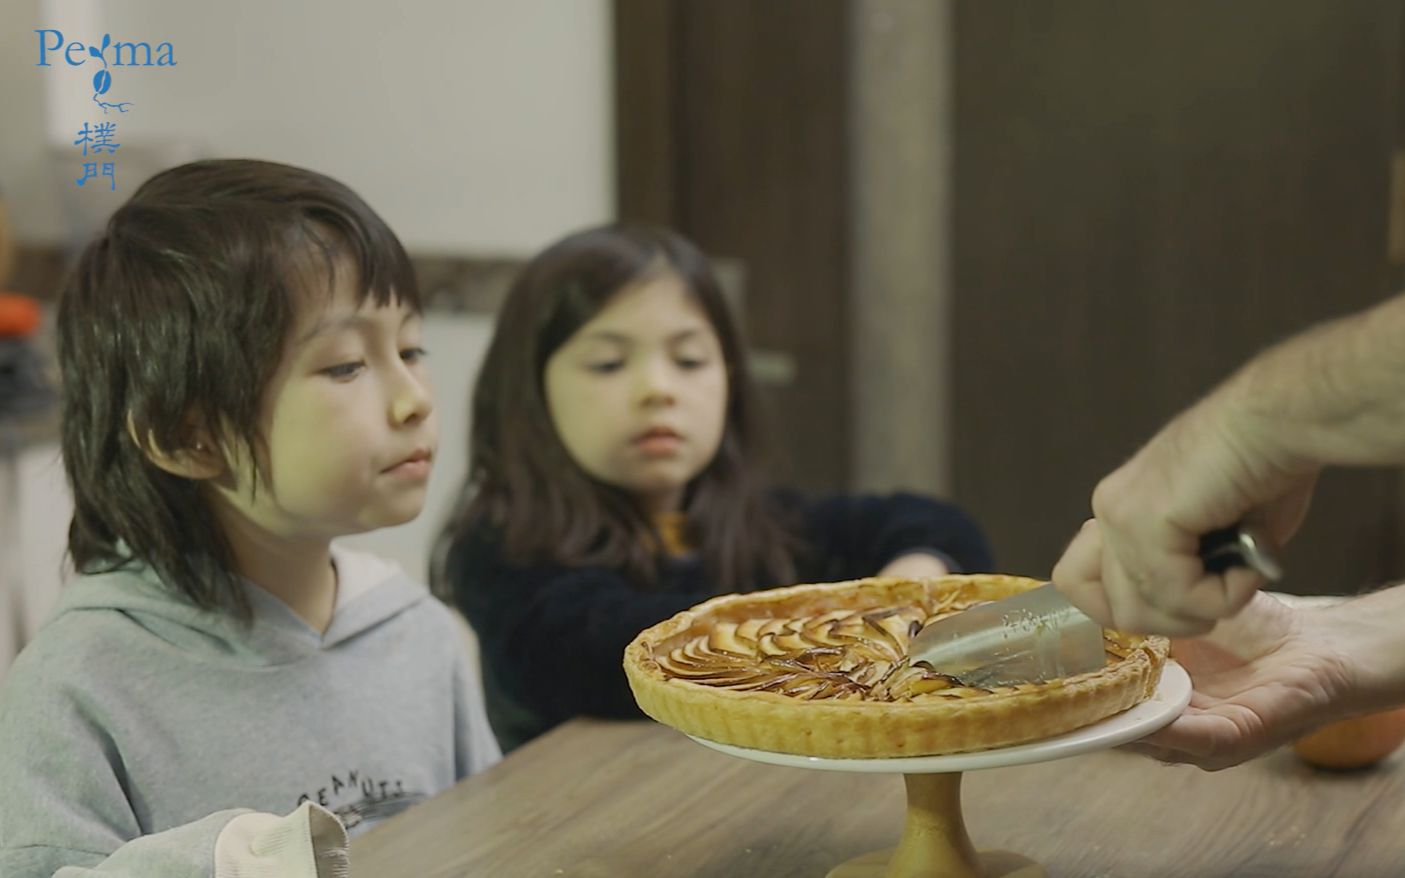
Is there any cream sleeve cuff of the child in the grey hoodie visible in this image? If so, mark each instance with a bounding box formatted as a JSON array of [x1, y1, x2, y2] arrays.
[[215, 802, 351, 878]]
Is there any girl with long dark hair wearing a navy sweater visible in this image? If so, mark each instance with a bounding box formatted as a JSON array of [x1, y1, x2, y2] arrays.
[[438, 226, 991, 750]]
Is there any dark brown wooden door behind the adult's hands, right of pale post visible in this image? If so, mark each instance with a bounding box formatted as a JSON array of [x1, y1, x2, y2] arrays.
[[953, 0, 1405, 593]]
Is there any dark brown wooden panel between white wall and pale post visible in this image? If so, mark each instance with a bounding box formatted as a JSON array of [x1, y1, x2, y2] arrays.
[[614, 0, 850, 490]]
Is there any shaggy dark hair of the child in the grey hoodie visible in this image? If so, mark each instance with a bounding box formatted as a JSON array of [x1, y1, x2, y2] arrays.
[[58, 159, 420, 621]]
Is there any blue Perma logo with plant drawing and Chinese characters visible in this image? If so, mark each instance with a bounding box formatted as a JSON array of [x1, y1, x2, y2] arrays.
[[34, 28, 176, 190]]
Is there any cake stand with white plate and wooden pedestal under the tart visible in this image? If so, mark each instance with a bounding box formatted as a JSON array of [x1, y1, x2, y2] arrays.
[[693, 662, 1191, 878]]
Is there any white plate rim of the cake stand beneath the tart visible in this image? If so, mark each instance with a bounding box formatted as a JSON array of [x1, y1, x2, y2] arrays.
[[688, 660, 1191, 774]]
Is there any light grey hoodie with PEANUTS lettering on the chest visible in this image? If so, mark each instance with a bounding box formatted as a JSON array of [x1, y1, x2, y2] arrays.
[[0, 549, 499, 878]]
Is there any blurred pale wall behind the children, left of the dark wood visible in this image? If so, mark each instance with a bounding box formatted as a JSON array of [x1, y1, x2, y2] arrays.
[[0, 0, 614, 254]]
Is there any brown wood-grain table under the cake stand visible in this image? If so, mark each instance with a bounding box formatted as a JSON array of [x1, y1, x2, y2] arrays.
[[351, 719, 1405, 878]]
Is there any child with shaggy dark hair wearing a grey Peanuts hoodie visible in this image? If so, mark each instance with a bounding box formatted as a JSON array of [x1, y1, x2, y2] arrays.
[[0, 162, 497, 878]]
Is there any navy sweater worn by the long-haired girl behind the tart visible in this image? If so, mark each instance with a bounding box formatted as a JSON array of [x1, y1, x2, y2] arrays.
[[445, 494, 991, 753]]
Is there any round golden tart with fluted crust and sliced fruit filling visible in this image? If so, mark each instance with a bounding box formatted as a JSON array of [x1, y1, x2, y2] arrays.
[[624, 575, 1169, 759]]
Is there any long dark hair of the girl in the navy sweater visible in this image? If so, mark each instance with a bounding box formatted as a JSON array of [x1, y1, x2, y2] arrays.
[[436, 225, 794, 593]]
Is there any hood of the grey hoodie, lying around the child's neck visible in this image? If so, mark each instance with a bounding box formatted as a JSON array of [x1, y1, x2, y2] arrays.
[[49, 545, 433, 664]]
